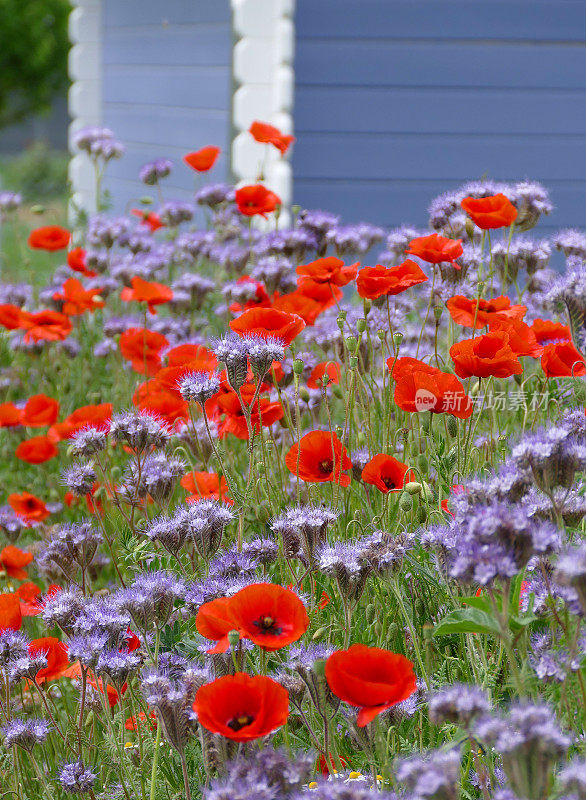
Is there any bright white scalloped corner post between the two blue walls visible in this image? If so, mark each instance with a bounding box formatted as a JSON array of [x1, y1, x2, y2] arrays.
[[231, 0, 295, 224]]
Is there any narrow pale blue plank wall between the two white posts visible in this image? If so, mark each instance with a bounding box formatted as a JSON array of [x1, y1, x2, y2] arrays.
[[102, 0, 232, 212]]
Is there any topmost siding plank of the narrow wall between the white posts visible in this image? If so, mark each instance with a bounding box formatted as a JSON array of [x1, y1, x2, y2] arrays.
[[103, 0, 230, 28]]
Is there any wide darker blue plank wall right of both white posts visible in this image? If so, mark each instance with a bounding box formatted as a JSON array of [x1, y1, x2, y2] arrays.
[[293, 0, 586, 235]]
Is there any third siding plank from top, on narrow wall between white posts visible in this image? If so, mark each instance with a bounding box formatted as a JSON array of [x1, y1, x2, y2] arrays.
[[103, 66, 232, 109]]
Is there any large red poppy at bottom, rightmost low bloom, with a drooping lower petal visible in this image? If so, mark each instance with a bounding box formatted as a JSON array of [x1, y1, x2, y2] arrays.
[[326, 644, 417, 728]]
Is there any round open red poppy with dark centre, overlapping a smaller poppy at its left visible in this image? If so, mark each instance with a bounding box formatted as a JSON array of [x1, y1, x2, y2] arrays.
[[227, 583, 309, 650]]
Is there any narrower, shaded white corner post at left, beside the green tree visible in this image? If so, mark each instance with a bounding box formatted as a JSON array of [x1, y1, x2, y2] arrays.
[[69, 0, 102, 216]]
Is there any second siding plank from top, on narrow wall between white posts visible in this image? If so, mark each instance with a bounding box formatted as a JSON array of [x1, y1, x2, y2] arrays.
[[103, 23, 232, 67]]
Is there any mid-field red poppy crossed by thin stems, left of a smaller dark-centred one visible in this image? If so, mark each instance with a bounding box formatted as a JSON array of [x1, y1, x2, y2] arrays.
[[285, 431, 352, 486]]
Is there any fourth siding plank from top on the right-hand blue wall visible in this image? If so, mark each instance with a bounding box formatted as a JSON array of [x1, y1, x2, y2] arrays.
[[293, 133, 586, 181]]
